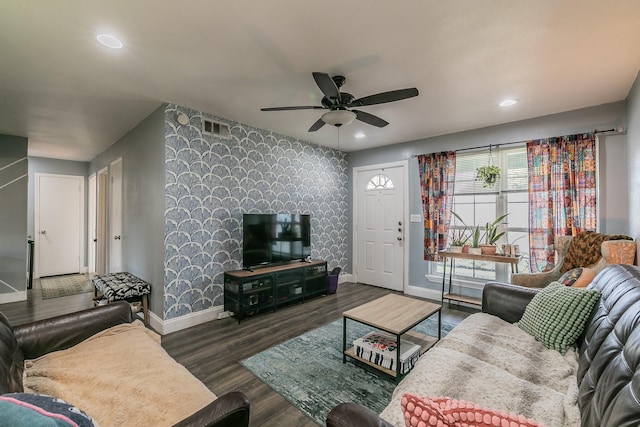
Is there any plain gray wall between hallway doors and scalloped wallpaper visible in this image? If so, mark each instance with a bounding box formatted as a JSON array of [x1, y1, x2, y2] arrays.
[[89, 105, 165, 318]]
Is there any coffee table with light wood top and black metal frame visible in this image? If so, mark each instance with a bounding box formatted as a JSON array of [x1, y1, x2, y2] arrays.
[[342, 294, 442, 380]]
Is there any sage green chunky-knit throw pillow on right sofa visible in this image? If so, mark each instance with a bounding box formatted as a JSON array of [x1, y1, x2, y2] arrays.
[[518, 282, 600, 354]]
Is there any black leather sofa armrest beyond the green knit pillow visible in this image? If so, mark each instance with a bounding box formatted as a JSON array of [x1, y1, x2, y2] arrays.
[[482, 282, 539, 323]]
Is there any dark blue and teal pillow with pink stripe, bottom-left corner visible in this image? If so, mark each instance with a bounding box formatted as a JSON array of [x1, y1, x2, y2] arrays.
[[0, 393, 96, 427]]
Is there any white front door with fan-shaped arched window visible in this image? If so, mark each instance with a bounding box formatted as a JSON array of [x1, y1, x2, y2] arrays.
[[354, 165, 405, 291]]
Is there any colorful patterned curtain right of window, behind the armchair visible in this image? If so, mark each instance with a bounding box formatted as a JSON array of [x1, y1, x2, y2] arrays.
[[527, 133, 596, 272]]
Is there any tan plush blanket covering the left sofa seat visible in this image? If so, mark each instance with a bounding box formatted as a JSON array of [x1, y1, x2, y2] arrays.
[[24, 320, 216, 427]]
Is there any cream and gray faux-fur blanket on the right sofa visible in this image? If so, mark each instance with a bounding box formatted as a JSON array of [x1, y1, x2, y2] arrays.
[[381, 313, 580, 427]]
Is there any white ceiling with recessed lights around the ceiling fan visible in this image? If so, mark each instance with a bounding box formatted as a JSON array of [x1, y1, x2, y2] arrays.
[[0, 0, 640, 161]]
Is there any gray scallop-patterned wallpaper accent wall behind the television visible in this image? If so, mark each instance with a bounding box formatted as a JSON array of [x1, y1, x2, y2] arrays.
[[164, 104, 348, 320]]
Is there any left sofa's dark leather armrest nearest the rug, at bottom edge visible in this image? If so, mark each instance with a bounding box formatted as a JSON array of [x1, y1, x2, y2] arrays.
[[174, 391, 249, 427]]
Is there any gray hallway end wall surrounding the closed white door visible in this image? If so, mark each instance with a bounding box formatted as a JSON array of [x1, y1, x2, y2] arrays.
[[27, 157, 89, 267]]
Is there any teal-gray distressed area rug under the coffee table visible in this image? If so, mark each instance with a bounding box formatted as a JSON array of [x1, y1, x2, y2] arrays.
[[240, 319, 455, 425]]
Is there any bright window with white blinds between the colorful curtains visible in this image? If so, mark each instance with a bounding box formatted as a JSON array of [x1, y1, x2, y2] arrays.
[[431, 146, 529, 282]]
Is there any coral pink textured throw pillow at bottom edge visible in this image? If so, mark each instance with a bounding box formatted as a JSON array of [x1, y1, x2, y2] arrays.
[[400, 393, 541, 427]]
